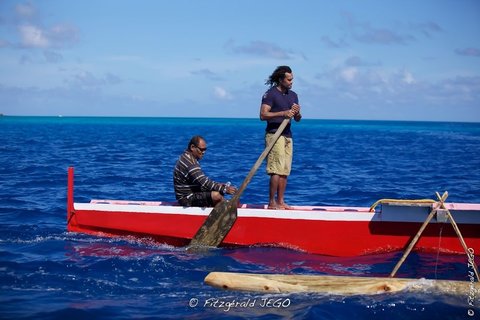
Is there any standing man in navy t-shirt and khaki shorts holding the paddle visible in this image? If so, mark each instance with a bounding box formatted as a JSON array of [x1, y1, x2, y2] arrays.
[[260, 66, 302, 210]]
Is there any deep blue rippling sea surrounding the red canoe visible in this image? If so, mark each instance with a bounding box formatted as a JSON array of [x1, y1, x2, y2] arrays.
[[0, 116, 480, 320]]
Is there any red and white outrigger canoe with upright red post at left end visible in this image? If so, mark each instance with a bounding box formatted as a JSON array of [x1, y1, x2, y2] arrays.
[[67, 168, 480, 256]]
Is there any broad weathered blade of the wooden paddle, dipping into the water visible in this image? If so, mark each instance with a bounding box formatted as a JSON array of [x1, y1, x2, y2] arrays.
[[189, 201, 237, 247]]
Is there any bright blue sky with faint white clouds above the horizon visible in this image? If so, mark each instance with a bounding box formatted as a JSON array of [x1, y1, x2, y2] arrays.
[[0, 0, 480, 122]]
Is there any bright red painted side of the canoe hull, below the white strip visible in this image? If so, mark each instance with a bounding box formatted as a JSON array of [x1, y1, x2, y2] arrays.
[[68, 204, 480, 256]]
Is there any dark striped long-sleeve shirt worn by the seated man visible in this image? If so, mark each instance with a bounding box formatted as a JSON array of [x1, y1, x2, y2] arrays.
[[173, 151, 224, 200]]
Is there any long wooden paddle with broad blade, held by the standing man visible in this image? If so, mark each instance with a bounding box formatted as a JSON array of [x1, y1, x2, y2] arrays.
[[189, 118, 290, 247]]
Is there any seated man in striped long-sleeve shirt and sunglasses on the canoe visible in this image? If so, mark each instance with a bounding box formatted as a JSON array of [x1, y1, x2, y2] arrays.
[[173, 136, 237, 207]]
